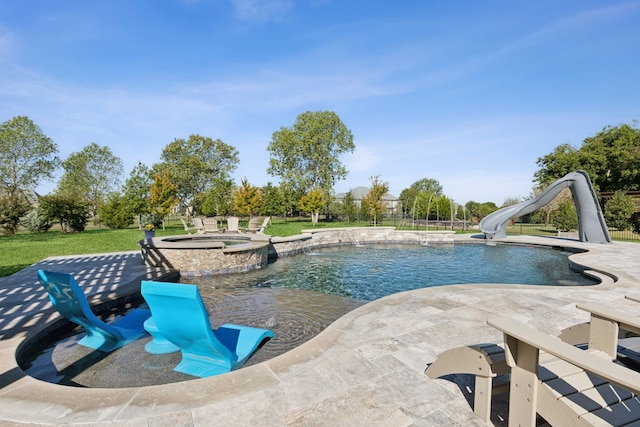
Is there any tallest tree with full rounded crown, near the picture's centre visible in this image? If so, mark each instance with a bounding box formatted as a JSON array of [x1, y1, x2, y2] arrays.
[[267, 111, 355, 198]]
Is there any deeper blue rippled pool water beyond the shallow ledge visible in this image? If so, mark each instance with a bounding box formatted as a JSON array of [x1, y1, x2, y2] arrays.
[[190, 244, 597, 301]]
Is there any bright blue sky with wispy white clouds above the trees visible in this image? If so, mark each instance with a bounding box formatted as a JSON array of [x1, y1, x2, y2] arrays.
[[0, 0, 640, 205]]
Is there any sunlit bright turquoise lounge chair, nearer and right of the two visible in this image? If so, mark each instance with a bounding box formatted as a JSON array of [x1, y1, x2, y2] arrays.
[[142, 280, 275, 377]]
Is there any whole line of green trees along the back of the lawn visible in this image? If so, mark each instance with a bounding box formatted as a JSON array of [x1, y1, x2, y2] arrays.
[[0, 111, 640, 234]]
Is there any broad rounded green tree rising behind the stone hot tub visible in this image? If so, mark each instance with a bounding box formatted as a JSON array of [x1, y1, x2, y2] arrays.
[[160, 135, 238, 213]]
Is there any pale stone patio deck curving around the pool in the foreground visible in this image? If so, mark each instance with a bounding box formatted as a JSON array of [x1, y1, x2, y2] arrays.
[[0, 236, 640, 426]]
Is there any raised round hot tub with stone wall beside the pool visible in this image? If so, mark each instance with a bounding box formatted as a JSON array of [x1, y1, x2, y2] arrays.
[[138, 233, 269, 277]]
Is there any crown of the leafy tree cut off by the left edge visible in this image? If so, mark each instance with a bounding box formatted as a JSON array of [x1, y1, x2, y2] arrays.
[[0, 116, 59, 196]]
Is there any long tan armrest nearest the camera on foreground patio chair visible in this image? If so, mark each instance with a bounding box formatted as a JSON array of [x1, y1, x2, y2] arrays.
[[487, 317, 640, 394]]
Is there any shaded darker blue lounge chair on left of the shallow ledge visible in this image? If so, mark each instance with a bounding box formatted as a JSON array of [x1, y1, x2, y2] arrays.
[[38, 270, 151, 352]]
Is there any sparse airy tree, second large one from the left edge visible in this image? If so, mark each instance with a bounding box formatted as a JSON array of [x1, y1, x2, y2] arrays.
[[57, 142, 124, 215]]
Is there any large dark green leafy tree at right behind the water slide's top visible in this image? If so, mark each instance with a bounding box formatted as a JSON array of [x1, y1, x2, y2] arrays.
[[534, 122, 640, 192]]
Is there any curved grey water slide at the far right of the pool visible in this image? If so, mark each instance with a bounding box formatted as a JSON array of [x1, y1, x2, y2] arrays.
[[480, 170, 611, 243]]
